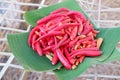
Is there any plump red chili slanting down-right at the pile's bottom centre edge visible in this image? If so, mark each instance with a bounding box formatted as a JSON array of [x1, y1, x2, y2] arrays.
[[55, 48, 71, 70]]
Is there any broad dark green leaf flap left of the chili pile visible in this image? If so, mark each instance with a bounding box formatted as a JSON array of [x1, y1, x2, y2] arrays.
[[7, 33, 60, 71]]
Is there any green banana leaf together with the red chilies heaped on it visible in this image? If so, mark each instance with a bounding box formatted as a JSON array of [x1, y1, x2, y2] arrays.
[[7, 0, 120, 80]]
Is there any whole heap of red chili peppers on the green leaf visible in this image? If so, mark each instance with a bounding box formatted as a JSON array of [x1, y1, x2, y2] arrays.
[[28, 8, 103, 70]]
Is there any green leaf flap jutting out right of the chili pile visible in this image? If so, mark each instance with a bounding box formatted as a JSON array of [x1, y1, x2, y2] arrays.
[[95, 28, 120, 61]]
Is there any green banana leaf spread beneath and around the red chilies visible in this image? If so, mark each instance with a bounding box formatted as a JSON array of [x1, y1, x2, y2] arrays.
[[7, 0, 120, 80]]
